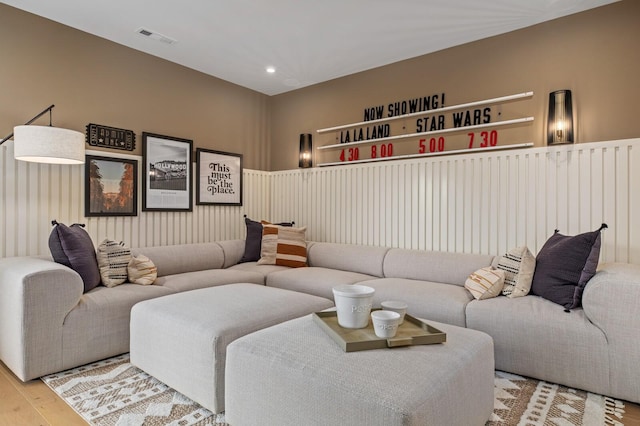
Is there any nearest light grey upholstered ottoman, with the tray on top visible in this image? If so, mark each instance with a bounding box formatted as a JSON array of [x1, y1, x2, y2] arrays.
[[225, 315, 494, 426]]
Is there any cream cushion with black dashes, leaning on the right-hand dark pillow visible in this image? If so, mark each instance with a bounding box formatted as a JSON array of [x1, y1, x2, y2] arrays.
[[496, 246, 536, 297]]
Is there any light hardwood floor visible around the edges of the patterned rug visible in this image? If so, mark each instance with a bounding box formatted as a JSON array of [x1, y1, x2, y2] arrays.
[[0, 362, 640, 426]]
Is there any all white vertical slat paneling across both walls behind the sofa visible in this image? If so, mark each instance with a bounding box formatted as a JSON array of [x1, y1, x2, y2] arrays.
[[0, 139, 640, 263]]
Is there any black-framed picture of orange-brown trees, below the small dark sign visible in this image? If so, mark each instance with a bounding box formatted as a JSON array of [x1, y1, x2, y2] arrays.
[[84, 155, 138, 217]]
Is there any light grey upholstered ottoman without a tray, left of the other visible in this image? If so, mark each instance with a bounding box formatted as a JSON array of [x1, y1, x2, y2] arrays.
[[130, 283, 333, 413]]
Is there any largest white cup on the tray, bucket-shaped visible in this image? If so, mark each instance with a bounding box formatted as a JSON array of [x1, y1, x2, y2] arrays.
[[333, 284, 375, 328]]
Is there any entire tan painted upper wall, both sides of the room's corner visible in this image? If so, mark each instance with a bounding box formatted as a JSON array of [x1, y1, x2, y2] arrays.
[[0, 0, 640, 170]]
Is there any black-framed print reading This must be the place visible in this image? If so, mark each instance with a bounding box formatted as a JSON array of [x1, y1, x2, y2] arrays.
[[196, 148, 242, 206]]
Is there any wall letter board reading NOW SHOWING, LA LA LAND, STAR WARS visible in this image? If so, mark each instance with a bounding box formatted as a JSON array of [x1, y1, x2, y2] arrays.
[[316, 91, 534, 167]]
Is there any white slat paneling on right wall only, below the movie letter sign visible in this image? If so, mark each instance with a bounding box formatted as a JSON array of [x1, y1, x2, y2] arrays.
[[272, 139, 640, 263]]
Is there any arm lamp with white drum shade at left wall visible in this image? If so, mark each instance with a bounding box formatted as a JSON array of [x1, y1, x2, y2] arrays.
[[0, 105, 85, 164]]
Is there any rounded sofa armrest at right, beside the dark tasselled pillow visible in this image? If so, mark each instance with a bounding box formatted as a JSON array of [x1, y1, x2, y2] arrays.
[[582, 263, 640, 402]]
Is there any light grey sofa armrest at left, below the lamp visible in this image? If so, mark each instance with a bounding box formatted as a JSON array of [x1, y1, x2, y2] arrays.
[[0, 257, 84, 381]]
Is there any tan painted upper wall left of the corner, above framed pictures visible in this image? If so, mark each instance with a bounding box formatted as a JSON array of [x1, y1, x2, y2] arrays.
[[0, 4, 271, 170]]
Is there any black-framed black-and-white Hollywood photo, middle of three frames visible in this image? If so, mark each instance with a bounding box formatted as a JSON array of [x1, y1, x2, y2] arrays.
[[142, 132, 193, 212]]
